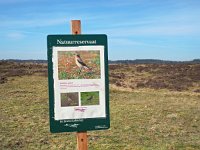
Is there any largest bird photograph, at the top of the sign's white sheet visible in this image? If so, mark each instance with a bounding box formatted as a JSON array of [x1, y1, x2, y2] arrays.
[[58, 50, 101, 80]]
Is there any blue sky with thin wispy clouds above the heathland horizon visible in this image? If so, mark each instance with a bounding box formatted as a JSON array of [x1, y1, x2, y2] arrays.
[[0, 0, 200, 60]]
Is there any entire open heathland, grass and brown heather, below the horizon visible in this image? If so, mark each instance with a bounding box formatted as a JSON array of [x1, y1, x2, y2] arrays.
[[0, 61, 200, 150]]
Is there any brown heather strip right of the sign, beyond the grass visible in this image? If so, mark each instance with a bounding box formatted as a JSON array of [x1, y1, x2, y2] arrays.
[[109, 64, 200, 92]]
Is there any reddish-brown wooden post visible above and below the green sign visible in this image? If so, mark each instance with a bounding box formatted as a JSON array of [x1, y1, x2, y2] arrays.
[[71, 20, 88, 150]]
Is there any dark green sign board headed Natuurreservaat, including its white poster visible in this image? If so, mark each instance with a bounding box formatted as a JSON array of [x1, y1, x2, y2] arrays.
[[47, 35, 110, 133]]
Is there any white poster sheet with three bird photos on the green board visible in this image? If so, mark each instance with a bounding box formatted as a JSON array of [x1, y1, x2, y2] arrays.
[[52, 46, 106, 120]]
